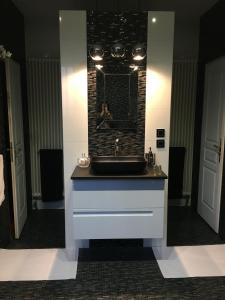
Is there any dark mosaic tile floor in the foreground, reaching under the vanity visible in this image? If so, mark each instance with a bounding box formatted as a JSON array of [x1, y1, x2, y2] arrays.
[[0, 247, 225, 300]]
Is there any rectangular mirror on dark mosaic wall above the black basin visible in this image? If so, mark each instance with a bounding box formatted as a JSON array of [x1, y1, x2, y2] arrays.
[[96, 67, 138, 130]]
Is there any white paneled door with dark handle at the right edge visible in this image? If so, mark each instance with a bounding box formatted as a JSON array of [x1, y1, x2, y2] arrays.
[[198, 57, 225, 233]]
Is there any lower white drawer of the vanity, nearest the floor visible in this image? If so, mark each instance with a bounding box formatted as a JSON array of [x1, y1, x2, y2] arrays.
[[73, 208, 164, 239]]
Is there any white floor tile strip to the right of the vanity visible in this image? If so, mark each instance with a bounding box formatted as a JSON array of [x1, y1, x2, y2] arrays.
[[157, 245, 225, 278]]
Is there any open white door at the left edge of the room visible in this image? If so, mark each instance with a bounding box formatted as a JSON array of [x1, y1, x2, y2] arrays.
[[6, 59, 27, 239]]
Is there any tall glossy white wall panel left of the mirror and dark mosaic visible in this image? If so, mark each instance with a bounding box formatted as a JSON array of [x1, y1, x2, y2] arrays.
[[60, 11, 88, 258]]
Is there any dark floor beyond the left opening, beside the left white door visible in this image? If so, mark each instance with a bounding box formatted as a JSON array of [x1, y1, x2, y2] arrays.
[[7, 209, 65, 249]]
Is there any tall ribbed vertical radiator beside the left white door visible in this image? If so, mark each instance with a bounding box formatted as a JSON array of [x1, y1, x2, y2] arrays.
[[27, 59, 62, 196]]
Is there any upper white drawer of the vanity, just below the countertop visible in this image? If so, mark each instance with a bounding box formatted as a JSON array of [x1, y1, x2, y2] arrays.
[[71, 190, 164, 211]]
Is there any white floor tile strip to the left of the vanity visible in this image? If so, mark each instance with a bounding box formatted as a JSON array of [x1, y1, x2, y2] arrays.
[[0, 249, 77, 281]]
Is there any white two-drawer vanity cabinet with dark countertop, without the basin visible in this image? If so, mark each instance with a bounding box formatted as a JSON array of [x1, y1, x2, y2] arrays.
[[70, 166, 167, 240]]
